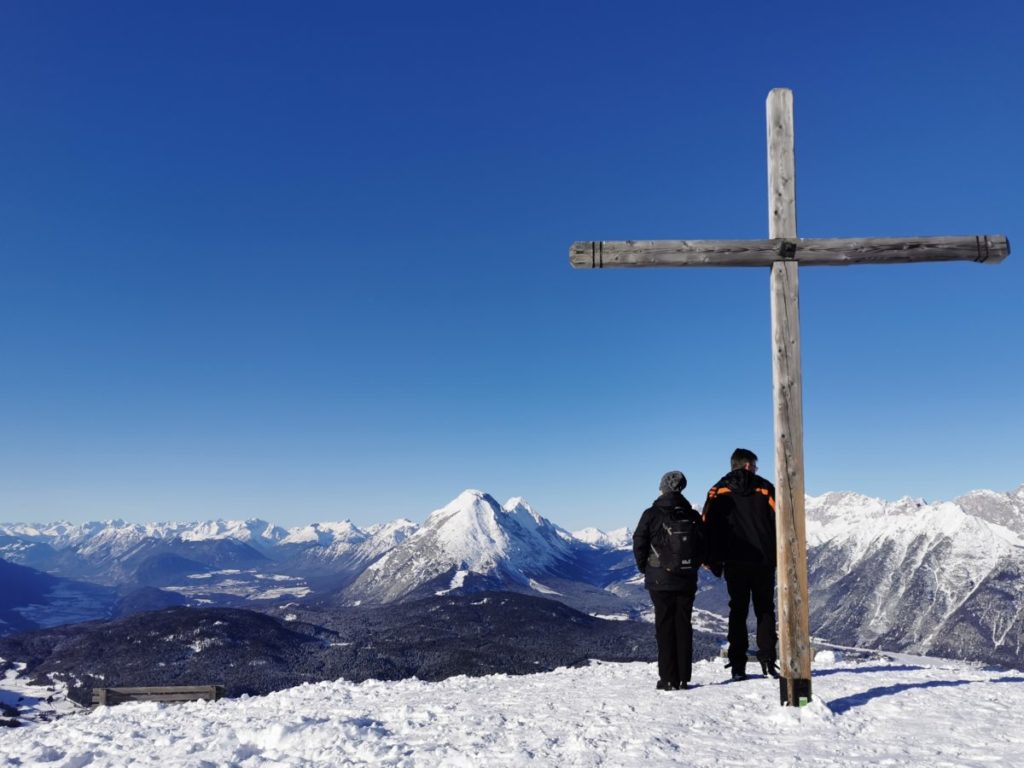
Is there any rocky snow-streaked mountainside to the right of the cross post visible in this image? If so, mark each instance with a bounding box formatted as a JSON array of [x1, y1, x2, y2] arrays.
[[807, 493, 1024, 664]]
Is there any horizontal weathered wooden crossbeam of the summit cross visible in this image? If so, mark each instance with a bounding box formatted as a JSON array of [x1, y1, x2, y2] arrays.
[[569, 234, 1010, 269]]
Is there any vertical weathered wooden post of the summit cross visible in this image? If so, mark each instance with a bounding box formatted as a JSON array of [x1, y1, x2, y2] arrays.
[[765, 88, 811, 706]]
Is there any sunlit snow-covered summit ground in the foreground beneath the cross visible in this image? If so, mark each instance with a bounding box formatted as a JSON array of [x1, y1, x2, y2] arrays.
[[0, 651, 1024, 768]]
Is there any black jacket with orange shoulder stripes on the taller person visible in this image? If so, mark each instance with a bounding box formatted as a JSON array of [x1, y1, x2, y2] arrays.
[[703, 469, 775, 566]]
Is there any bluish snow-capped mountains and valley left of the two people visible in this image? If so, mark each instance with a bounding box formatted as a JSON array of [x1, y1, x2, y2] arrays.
[[0, 490, 649, 626]]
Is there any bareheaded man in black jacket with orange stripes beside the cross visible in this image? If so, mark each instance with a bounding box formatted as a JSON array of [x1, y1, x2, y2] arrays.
[[702, 449, 778, 680]]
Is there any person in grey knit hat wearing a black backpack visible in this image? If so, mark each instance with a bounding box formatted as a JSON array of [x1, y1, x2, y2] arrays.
[[633, 471, 703, 690]]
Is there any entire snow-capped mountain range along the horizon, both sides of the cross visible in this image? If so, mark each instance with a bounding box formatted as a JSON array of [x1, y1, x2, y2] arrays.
[[0, 486, 1024, 666]]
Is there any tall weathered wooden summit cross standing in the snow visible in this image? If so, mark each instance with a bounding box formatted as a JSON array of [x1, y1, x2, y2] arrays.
[[569, 88, 1010, 706]]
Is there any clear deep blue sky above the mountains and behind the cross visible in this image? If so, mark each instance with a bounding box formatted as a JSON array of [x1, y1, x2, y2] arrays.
[[0, 0, 1024, 528]]
